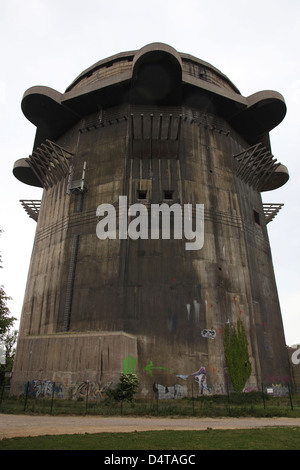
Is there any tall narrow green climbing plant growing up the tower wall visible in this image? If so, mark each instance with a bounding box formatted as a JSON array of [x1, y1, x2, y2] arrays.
[[224, 319, 252, 392]]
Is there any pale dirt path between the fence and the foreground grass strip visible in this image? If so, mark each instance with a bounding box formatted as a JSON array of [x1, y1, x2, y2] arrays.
[[0, 414, 300, 439]]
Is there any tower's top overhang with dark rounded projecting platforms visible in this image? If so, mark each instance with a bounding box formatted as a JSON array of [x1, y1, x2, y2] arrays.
[[14, 43, 286, 187]]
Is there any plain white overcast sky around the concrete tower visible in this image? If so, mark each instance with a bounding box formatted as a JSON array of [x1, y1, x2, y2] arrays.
[[0, 0, 300, 345]]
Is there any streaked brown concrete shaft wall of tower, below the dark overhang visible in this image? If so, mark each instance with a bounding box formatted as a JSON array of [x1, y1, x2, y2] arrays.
[[16, 107, 286, 392]]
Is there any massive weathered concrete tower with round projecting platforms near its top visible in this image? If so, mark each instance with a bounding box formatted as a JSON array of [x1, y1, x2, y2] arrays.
[[12, 43, 290, 396]]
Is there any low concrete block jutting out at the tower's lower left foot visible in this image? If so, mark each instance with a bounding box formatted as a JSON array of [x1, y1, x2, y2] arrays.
[[11, 332, 137, 398]]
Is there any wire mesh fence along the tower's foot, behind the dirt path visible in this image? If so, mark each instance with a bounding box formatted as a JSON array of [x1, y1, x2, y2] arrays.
[[0, 380, 300, 417]]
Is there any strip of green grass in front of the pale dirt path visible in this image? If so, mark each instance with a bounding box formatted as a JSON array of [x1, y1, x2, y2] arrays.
[[0, 427, 300, 451]]
